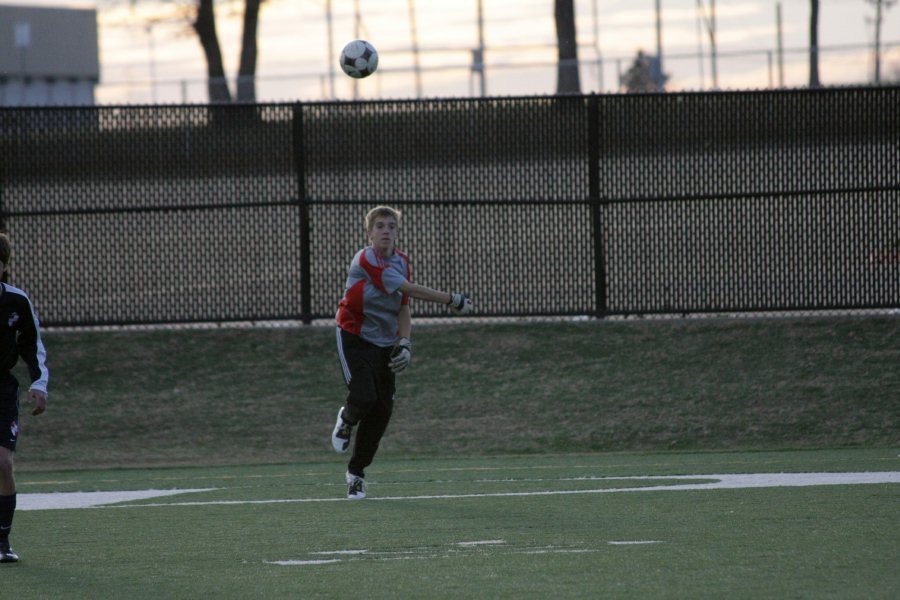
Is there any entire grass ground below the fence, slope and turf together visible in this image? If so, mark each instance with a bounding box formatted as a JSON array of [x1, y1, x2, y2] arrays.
[[7, 317, 900, 599]]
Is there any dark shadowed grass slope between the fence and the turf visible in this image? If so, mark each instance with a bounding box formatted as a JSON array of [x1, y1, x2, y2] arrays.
[[17, 317, 900, 470]]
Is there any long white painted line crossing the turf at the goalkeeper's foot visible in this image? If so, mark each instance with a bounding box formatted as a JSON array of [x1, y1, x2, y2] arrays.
[[18, 471, 900, 510]]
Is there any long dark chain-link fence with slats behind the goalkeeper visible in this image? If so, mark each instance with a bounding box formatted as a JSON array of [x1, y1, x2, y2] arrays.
[[0, 87, 900, 326]]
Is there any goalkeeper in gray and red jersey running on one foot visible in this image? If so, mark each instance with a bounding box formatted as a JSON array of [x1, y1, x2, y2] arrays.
[[331, 206, 472, 500]]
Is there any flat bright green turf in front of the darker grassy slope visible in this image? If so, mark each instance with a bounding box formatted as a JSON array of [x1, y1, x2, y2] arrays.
[[7, 448, 900, 599]]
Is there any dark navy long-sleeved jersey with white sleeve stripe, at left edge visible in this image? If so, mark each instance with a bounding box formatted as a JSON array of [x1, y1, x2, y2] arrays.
[[0, 283, 50, 393]]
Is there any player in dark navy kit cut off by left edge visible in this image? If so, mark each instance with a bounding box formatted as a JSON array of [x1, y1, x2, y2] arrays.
[[0, 233, 49, 563]]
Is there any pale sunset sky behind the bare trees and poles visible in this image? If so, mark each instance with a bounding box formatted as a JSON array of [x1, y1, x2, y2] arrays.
[[7, 0, 900, 104]]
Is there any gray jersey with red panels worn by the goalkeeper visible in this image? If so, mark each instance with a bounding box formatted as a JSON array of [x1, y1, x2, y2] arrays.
[[337, 246, 412, 347]]
